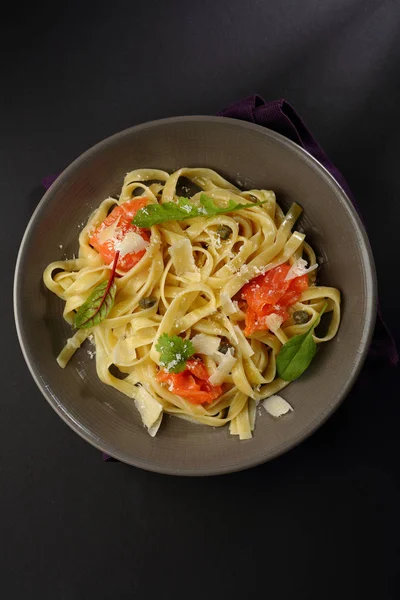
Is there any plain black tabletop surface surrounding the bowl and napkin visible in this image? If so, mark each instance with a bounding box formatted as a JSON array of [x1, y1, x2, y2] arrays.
[[0, 0, 400, 600]]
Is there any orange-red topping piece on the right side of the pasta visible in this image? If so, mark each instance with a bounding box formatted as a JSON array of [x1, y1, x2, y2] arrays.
[[240, 264, 308, 336]]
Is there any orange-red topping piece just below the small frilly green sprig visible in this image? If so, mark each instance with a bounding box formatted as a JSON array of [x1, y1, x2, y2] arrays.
[[157, 359, 222, 404]]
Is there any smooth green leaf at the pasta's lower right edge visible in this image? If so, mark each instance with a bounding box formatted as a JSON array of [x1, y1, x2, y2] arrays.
[[276, 303, 328, 381]]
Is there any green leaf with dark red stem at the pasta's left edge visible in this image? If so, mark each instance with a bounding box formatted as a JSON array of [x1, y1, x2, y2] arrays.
[[74, 252, 119, 329]]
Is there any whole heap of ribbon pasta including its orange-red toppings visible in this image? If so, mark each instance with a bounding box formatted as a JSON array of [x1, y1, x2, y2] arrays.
[[43, 168, 340, 439]]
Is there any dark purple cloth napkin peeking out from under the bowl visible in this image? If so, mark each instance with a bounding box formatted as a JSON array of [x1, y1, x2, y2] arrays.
[[42, 95, 399, 461]]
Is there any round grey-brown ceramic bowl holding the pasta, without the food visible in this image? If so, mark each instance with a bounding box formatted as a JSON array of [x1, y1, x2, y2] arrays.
[[15, 116, 376, 475]]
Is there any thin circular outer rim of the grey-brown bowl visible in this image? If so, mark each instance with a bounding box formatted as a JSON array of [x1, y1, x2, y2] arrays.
[[13, 115, 377, 476]]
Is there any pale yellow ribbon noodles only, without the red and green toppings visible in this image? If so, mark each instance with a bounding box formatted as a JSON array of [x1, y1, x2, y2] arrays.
[[43, 168, 340, 439]]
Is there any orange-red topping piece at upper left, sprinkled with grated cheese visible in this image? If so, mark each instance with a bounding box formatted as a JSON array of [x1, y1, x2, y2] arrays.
[[89, 198, 150, 271]]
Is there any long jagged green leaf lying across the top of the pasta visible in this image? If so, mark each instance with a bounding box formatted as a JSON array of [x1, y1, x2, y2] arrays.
[[132, 194, 267, 228]]
